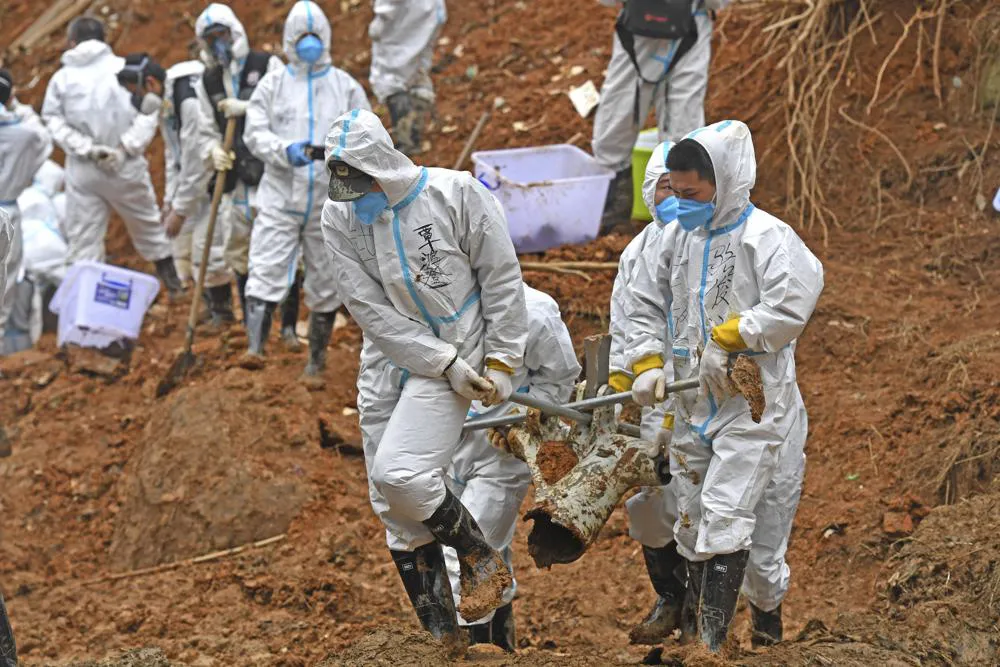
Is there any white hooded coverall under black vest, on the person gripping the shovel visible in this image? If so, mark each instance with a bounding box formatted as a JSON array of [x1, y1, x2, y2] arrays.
[[194, 2, 285, 275]]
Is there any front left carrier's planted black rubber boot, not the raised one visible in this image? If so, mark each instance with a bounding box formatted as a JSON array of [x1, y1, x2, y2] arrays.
[[390, 542, 459, 640]]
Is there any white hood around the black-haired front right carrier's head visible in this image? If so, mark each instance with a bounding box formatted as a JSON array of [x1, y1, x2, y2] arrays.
[[685, 120, 757, 229]]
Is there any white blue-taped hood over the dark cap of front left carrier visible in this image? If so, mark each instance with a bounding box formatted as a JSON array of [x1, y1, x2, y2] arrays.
[[326, 109, 420, 206]]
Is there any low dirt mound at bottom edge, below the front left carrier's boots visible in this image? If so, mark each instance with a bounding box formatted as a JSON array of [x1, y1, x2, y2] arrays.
[[319, 626, 451, 667]]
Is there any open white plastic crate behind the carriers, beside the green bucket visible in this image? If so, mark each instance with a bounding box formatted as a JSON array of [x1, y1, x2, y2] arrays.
[[472, 144, 615, 253]]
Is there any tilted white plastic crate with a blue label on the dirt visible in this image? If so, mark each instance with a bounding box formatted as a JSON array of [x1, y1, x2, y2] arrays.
[[49, 261, 160, 348]]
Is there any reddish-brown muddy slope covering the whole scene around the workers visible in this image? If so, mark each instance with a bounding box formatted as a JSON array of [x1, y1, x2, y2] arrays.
[[0, 0, 1000, 666]]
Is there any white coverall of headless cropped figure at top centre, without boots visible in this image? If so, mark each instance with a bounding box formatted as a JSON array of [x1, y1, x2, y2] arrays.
[[368, 0, 448, 103]]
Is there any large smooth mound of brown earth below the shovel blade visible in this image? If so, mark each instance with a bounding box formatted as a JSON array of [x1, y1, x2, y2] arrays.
[[105, 370, 310, 568]]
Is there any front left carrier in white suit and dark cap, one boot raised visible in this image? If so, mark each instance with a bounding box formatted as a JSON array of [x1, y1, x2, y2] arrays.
[[323, 109, 528, 640]]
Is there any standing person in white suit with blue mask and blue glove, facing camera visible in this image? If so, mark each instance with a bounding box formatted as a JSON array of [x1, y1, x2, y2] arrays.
[[243, 0, 370, 376]]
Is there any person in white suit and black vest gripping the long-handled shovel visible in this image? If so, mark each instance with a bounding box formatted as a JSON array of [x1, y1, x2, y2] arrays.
[[194, 2, 284, 321]]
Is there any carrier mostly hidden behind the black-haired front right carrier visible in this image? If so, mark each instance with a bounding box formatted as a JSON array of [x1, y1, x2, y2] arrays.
[[608, 141, 687, 644]]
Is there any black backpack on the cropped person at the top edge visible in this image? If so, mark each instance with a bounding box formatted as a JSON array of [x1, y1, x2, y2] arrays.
[[615, 0, 698, 124]]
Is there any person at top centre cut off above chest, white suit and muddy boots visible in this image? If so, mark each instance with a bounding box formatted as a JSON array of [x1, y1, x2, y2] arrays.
[[368, 0, 448, 155]]
